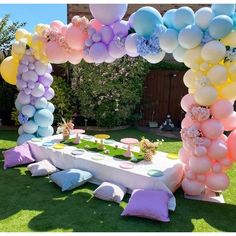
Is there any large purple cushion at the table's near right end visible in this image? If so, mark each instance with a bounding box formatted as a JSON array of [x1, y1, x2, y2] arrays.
[[121, 189, 171, 222]]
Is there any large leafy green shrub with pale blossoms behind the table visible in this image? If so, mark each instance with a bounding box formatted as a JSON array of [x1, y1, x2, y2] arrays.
[[72, 57, 148, 127]]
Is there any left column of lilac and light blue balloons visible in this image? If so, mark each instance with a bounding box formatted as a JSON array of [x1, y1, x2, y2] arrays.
[[15, 49, 55, 145]]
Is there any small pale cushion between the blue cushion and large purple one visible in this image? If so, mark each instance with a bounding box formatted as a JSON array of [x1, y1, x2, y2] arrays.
[[93, 182, 127, 203]]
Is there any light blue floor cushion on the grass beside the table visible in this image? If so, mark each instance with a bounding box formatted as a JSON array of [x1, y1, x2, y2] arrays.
[[49, 169, 93, 191]]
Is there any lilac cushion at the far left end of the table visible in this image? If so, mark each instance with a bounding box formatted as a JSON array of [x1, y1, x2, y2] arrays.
[[2, 143, 35, 169]]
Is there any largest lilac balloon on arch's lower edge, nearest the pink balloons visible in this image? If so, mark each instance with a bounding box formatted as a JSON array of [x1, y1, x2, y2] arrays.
[[89, 43, 107, 63]]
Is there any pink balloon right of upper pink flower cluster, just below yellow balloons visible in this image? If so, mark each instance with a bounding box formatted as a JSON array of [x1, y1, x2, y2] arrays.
[[210, 100, 234, 119]]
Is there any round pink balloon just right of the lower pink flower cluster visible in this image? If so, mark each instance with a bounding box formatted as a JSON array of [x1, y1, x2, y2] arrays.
[[201, 119, 224, 139]]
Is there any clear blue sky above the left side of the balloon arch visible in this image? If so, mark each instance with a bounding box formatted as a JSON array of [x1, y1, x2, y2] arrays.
[[0, 4, 67, 32]]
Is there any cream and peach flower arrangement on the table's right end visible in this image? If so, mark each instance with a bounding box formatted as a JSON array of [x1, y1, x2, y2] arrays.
[[139, 137, 164, 161]]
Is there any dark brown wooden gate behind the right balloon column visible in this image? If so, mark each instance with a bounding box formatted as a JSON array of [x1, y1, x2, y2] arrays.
[[140, 70, 188, 126]]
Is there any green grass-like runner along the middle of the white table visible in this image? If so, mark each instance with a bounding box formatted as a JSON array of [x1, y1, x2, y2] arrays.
[[63, 138, 144, 162]]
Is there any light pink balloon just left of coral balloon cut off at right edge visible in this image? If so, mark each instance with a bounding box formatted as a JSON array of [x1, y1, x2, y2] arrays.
[[208, 139, 228, 160]]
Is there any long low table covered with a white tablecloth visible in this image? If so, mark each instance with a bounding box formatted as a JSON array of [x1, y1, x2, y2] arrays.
[[28, 135, 183, 210]]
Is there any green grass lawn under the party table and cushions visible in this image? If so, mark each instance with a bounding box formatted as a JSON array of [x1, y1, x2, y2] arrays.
[[0, 128, 236, 232]]
